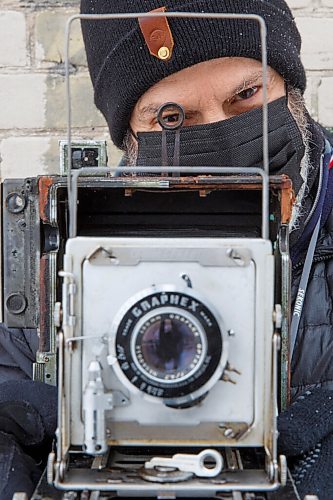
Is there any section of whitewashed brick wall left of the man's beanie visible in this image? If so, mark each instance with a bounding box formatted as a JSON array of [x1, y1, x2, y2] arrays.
[[0, 0, 119, 179]]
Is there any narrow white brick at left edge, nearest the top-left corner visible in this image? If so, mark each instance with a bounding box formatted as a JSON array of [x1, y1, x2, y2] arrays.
[[0, 11, 27, 66]]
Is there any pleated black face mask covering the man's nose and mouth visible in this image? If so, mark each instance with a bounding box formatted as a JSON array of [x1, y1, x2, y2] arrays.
[[137, 97, 305, 193]]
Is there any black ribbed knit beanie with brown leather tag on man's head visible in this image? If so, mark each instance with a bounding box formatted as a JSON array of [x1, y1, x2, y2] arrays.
[[81, 0, 306, 147]]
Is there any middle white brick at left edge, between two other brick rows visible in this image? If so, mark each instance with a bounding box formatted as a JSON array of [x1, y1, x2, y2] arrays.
[[0, 74, 46, 129]]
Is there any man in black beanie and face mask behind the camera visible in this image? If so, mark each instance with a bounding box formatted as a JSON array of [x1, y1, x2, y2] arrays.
[[81, 0, 333, 499]]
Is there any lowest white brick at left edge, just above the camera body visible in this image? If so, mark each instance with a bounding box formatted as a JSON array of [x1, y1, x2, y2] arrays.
[[0, 137, 52, 179]]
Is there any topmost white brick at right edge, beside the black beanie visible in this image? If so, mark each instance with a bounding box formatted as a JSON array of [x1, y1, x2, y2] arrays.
[[296, 17, 333, 70]]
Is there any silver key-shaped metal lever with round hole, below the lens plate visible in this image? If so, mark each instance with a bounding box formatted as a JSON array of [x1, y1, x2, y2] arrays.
[[145, 449, 223, 477]]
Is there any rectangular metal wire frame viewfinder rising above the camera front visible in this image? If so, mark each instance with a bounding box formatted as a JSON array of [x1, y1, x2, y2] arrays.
[[65, 12, 269, 239]]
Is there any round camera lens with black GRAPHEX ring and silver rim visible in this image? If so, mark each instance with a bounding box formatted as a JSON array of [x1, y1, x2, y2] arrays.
[[110, 285, 228, 408]]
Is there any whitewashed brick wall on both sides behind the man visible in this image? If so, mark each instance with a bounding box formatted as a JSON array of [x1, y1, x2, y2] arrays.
[[0, 0, 333, 178]]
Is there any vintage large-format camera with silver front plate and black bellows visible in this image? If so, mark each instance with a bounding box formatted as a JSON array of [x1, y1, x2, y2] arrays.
[[3, 9, 293, 498]]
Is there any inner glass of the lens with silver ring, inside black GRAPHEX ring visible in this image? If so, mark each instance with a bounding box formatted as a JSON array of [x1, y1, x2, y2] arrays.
[[133, 313, 206, 383]]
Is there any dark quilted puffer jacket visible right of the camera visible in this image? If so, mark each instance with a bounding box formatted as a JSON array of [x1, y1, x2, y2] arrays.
[[291, 131, 333, 400]]
